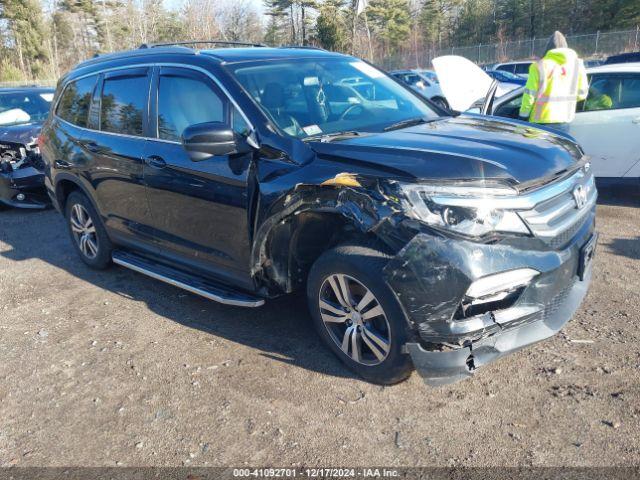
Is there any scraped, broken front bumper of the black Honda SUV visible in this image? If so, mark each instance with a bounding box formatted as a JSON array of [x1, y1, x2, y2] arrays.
[[385, 210, 597, 386]]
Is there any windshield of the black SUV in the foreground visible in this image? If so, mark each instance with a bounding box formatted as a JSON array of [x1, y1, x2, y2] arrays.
[[232, 58, 438, 138]]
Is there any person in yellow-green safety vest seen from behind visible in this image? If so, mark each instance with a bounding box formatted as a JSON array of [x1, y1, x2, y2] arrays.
[[520, 32, 589, 128]]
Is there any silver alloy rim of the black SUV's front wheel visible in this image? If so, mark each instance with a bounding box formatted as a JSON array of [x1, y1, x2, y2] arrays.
[[318, 273, 391, 366]]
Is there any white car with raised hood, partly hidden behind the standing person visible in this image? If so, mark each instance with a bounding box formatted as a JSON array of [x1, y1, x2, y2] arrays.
[[433, 57, 640, 185]]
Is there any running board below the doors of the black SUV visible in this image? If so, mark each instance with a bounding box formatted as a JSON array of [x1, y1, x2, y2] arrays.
[[112, 250, 264, 307]]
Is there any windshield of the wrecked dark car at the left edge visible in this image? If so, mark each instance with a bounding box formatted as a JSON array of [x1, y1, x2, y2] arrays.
[[0, 91, 53, 126]]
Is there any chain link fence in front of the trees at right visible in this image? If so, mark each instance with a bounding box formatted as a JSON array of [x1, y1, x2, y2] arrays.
[[381, 26, 640, 69]]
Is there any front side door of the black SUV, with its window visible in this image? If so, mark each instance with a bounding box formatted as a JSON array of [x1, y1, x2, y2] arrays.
[[144, 67, 252, 286]]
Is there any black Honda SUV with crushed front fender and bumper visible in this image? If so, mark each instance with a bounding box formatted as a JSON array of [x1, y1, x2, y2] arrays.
[[41, 41, 597, 385]]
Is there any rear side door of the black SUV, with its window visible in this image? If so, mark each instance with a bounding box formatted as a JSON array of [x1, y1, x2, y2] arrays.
[[90, 67, 156, 244]]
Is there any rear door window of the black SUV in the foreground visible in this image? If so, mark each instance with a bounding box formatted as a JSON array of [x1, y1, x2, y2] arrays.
[[100, 75, 149, 136]]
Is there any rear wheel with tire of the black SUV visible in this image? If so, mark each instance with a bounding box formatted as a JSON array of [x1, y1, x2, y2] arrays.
[[65, 191, 113, 270]]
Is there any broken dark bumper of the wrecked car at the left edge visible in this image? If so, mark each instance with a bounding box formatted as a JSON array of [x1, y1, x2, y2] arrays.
[[0, 167, 50, 209]]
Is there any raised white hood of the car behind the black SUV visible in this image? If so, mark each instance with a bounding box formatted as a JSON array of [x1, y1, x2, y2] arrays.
[[432, 55, 501, 112]]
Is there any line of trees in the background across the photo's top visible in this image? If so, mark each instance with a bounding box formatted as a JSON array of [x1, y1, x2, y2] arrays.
[[0, 0, 640, 81]]
